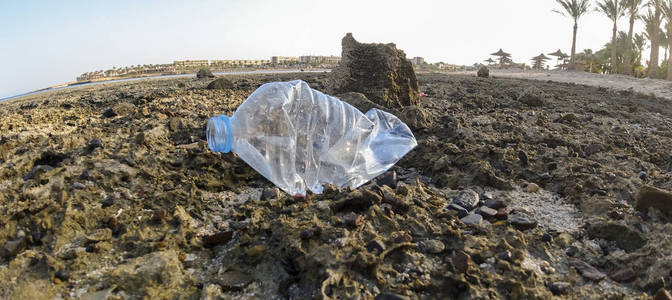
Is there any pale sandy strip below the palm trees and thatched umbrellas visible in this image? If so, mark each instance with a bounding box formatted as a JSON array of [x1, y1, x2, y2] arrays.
[[449, 69, 672, 99]]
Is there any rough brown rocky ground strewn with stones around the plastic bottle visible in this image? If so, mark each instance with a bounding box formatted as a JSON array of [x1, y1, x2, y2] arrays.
[[0, 73, 672, 299]]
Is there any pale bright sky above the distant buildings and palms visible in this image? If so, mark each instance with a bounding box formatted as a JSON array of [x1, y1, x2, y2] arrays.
[[0, 0, 662, 98]]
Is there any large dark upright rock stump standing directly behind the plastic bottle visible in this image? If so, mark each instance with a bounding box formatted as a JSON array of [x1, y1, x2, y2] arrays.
[[328, 33, 420, 108]]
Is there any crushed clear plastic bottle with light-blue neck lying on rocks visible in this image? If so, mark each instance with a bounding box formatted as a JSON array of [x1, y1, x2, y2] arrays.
[[206, 80, 417, 196]]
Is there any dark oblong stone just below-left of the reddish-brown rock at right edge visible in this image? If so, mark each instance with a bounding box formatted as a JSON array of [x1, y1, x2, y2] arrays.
[[588, 223, 646, 252]]
